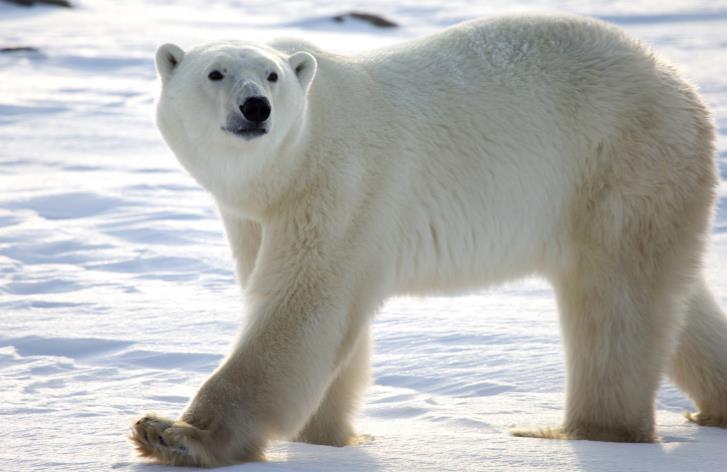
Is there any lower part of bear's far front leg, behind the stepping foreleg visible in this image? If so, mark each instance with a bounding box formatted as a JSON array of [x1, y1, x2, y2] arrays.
[[295, 328, 371, 447]]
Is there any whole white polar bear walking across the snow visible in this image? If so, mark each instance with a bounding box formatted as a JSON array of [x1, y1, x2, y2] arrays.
[[132, 16, 727, 466]]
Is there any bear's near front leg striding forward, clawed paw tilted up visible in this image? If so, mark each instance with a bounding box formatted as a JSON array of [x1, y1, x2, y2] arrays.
[[132, 243, 366, 467]]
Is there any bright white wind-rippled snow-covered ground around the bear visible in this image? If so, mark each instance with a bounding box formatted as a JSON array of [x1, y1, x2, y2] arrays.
[[0, 0, 727, 472]]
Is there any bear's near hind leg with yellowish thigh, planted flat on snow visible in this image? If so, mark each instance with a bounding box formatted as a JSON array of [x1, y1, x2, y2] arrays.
[[516, 100, 723, 442]]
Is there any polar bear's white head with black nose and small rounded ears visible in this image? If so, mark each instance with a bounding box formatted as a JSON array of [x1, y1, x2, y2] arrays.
[[156, 41, 317, 210]]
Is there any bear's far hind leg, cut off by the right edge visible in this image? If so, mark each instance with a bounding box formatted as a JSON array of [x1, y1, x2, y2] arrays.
[[668, 281, 727, 428]]
